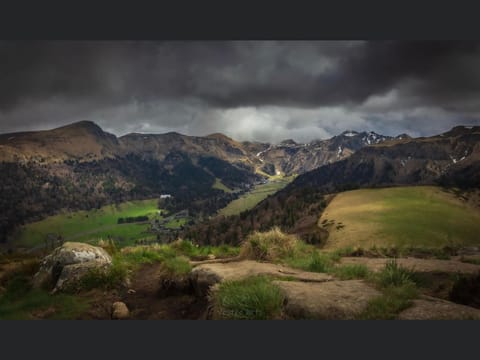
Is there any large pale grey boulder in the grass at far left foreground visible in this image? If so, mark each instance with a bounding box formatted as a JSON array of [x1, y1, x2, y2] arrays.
[[33, 242, 112, 292]]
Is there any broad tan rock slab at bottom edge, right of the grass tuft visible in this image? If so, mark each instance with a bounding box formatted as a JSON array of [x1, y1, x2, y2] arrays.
[[274, 280, 381, 320]]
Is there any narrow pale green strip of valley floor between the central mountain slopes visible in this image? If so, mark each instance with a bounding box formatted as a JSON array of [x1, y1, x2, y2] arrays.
[[219, 176, 294, 216]]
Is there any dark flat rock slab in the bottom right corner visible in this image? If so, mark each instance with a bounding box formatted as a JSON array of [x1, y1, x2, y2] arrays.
[[398, 296, 480, 320]]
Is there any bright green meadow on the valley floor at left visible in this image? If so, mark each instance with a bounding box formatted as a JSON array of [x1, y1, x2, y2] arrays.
[[16, 199, 162, 247]]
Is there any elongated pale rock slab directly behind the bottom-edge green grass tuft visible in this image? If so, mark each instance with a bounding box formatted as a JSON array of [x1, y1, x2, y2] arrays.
[[190, 260, 333, 296]]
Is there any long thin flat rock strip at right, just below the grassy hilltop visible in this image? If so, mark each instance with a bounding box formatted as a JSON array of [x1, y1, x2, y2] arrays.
[[341, 257, 480, 274]]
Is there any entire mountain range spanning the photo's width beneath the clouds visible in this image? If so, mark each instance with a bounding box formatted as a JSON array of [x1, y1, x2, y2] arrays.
[[0, 121, 480, 241]]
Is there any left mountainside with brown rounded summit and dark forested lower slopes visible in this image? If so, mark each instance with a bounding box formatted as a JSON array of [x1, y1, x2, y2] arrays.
[[0, 121, 261, 241]]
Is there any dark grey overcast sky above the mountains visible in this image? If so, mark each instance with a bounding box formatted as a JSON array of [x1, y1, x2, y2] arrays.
[[0, 41, 480, 142]]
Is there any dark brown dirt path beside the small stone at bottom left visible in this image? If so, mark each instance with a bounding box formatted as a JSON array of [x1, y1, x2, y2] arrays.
[[123, 264, 207, 320]]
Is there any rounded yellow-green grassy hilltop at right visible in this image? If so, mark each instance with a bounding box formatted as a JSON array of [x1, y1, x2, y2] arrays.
[[319, 186, 480, 249]]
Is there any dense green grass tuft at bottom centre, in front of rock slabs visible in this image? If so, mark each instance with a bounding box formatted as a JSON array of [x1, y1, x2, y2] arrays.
[[212, 276, 284, 320]]
